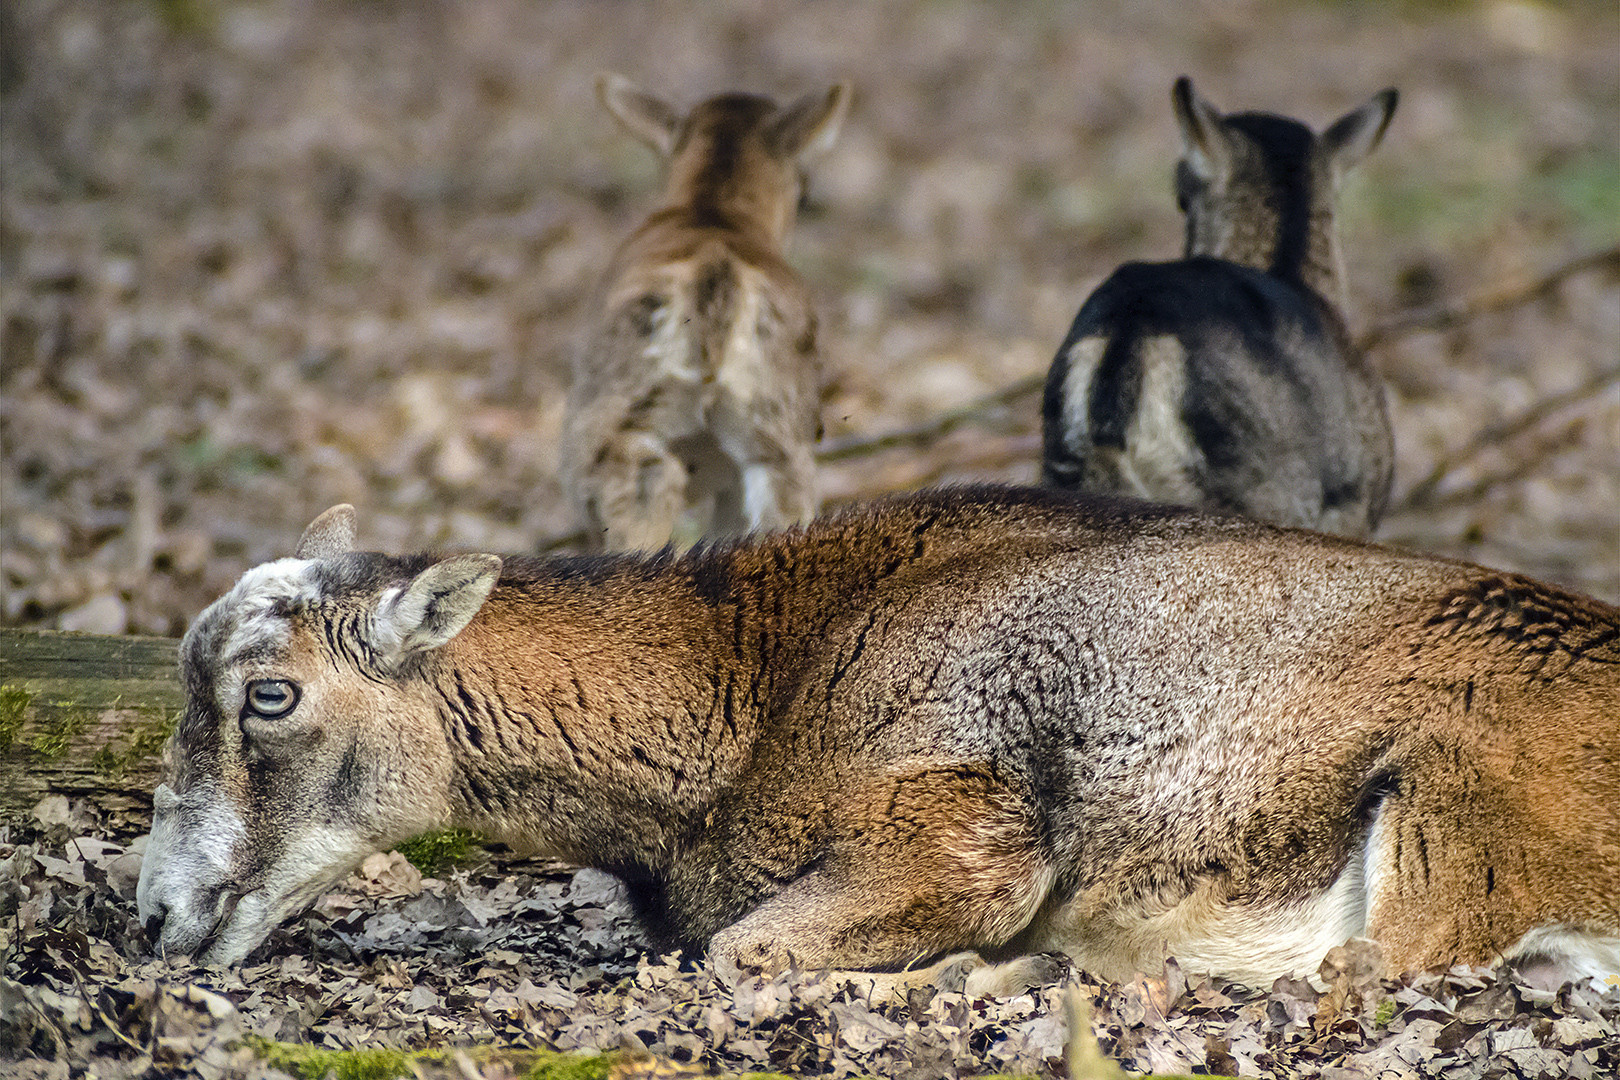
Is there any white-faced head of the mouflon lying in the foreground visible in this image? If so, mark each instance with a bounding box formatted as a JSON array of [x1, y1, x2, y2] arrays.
[[136, 505, 501, 965]]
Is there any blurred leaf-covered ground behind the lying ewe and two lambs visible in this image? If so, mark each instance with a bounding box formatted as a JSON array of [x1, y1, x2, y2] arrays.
[[0, 0, 1620, 635]]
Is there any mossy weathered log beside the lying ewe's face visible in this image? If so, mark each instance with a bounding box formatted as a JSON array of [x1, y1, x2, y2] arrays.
[[0, 628, 185, 821]]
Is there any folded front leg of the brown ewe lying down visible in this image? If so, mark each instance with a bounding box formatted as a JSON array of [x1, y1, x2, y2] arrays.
[[710, 764, 1055, 993]]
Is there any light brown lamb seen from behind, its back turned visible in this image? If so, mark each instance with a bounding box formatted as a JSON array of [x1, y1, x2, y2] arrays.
[[562, 74, 851, 551]]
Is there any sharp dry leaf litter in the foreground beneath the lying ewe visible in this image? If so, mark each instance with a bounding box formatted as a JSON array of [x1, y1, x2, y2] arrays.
[[0, 806, 1620, 1080]]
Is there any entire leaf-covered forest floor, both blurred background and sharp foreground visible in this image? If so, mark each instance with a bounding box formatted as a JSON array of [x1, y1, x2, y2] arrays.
[[0, 0, 1620, 1077]]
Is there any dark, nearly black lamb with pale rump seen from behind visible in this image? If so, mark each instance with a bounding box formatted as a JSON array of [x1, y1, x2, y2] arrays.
[[1042, 78, 1395, 536]]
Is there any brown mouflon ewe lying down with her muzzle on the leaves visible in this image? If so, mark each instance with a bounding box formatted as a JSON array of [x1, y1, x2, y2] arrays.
[[139, 487, 1620, 984]]
